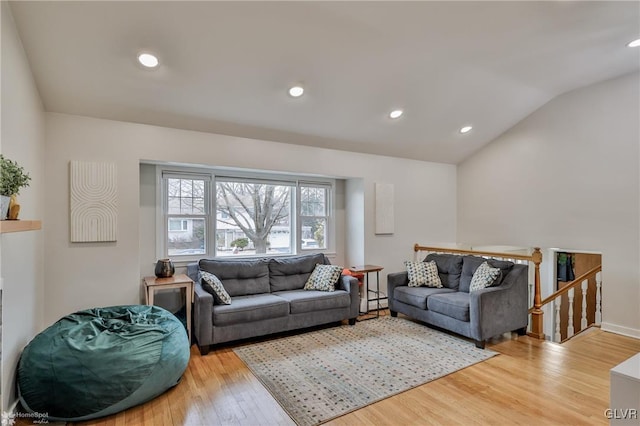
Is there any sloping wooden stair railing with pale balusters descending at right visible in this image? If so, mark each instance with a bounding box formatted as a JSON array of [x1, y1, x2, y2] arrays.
[[529, 265, 602, 342]]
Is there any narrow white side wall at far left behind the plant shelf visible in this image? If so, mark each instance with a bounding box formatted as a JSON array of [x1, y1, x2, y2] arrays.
[[0, 1, 46, 410]]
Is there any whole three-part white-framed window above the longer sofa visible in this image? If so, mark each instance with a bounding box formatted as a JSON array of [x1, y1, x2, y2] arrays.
[[157, 166, 333, 261]]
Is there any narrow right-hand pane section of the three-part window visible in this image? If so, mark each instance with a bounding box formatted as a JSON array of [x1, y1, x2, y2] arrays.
[[298, 183, 331, 250]]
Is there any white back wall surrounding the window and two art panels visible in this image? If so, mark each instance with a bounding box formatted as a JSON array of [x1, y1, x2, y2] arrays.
[[45, 113, 456, 323]]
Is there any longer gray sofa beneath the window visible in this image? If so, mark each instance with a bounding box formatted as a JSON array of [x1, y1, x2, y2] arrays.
[[187, 254, 360, 355]]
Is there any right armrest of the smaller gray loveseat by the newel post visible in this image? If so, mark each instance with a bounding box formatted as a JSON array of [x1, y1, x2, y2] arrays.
[[469, 265, 529, 340]]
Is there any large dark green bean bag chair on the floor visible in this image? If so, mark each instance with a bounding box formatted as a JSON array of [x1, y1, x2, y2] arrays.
[[18, 305, 189, 421]]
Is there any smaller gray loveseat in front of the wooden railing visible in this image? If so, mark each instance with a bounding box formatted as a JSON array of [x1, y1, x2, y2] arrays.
[[387, 254, 529, 348]]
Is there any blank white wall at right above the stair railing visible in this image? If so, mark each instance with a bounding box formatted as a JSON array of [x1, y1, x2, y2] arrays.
[[458, 73, 640, 337]]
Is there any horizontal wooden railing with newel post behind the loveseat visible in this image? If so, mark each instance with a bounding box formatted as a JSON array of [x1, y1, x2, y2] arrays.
[[413, 244, 544, 339]]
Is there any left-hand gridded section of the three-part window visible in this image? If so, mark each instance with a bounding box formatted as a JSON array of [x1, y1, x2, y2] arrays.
[[162, 172, 210, 256]]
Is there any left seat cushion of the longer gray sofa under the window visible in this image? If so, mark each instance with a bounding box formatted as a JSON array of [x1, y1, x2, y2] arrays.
[[213, 293, 289, 326]]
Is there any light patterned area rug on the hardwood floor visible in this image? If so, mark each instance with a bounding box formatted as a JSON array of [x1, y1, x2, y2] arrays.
[[233, 317, 497, 426]]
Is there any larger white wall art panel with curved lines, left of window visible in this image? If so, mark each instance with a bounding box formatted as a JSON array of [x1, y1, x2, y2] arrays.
[[69, 161, 118, 243]]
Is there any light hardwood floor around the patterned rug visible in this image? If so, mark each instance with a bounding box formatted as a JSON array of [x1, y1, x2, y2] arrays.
[[17, 314, 640, 426]]
